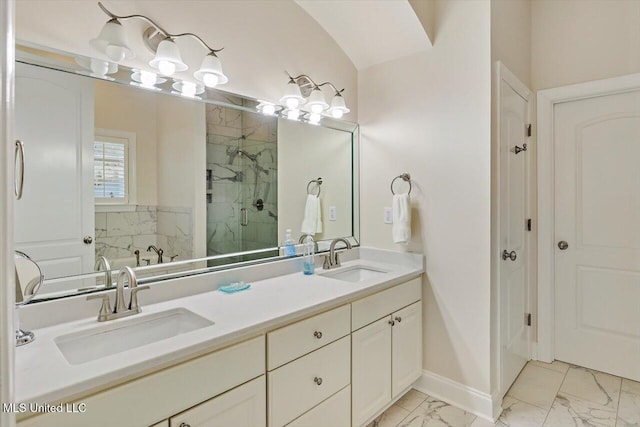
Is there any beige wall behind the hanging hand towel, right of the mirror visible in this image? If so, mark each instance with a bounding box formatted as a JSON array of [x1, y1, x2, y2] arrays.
[[358, 0, 491, 393]]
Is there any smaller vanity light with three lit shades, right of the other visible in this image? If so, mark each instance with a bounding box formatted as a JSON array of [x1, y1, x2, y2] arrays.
[[280, 73, 350, 120]]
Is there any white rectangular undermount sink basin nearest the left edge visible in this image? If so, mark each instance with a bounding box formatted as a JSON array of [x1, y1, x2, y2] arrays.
[[54, 308, 213, 365]]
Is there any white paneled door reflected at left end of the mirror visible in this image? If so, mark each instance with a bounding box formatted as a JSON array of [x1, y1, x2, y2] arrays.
[[14, 64, 95, 278]]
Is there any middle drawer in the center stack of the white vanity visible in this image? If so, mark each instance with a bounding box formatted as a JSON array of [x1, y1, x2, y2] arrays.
[[267, 336, 351, 427]]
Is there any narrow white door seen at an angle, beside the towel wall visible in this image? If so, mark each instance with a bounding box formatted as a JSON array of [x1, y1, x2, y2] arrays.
[[498, 70, 531, 394]]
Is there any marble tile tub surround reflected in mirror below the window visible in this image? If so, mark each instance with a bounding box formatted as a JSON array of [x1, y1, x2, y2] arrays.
[[95, 206, 193, 262]]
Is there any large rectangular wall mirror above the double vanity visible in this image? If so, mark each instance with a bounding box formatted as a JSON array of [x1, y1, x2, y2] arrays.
[[15, 43, 359, 300]]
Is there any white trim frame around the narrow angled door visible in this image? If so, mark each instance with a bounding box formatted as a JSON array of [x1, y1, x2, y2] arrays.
[[493, 61, 535, 397]]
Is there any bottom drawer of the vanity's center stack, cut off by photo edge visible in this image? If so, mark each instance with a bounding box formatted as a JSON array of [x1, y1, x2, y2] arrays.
[[287, 386, 351, 427]]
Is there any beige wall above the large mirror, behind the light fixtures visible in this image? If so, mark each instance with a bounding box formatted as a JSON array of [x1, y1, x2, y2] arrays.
[[16, 0, 358, 121]]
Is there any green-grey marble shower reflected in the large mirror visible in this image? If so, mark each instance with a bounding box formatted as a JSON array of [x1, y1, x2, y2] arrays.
[[207, 96, 277, 255]]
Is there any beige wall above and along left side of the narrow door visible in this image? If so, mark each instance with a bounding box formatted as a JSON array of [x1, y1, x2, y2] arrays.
[[491, 0, 536, 392]]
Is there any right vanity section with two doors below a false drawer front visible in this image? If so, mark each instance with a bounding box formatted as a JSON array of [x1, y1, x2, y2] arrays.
[[351, 279, 422, 427]]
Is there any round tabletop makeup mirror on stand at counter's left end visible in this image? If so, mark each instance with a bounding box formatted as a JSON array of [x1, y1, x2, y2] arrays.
[[14, 251, 44, 346]]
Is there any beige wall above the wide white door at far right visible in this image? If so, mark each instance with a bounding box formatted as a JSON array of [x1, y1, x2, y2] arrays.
[[531, 0, 640, 90]]
